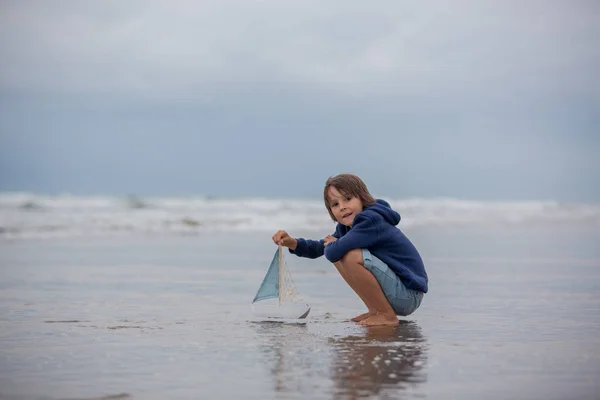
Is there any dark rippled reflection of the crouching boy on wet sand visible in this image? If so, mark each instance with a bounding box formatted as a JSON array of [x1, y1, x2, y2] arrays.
[[330, 321, 427, 399]]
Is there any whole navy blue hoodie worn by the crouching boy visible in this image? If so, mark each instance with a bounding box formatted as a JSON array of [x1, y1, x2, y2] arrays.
[[290, 199, 428, 293]]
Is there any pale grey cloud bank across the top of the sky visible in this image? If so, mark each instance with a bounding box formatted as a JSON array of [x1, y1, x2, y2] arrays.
[[0, 0, 600, 98]]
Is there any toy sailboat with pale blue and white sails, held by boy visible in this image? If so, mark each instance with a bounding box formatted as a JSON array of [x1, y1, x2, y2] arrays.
[[252, 246, 310, 319]]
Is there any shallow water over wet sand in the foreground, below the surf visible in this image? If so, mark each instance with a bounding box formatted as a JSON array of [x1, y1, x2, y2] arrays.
[[0, 229, 600, 399]]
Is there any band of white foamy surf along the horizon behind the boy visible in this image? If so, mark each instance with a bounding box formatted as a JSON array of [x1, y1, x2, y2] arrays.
[[0, 193, 600, 239]]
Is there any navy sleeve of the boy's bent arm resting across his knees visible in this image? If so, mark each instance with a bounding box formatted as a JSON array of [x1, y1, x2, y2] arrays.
[[324, 214, 379, 263]]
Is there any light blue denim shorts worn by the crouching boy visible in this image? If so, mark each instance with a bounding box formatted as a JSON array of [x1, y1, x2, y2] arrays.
[[362, 249, 423, 316]]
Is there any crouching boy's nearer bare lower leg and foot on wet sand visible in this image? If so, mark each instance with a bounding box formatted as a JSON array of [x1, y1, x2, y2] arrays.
[[334, 249, 398, 325]]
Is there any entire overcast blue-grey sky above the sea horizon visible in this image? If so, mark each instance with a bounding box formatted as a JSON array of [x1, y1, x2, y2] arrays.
[[0, 0, 600, 202]]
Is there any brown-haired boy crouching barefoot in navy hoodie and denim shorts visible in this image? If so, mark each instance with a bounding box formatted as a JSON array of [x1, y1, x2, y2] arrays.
[[273, 174, 428, 326]]
